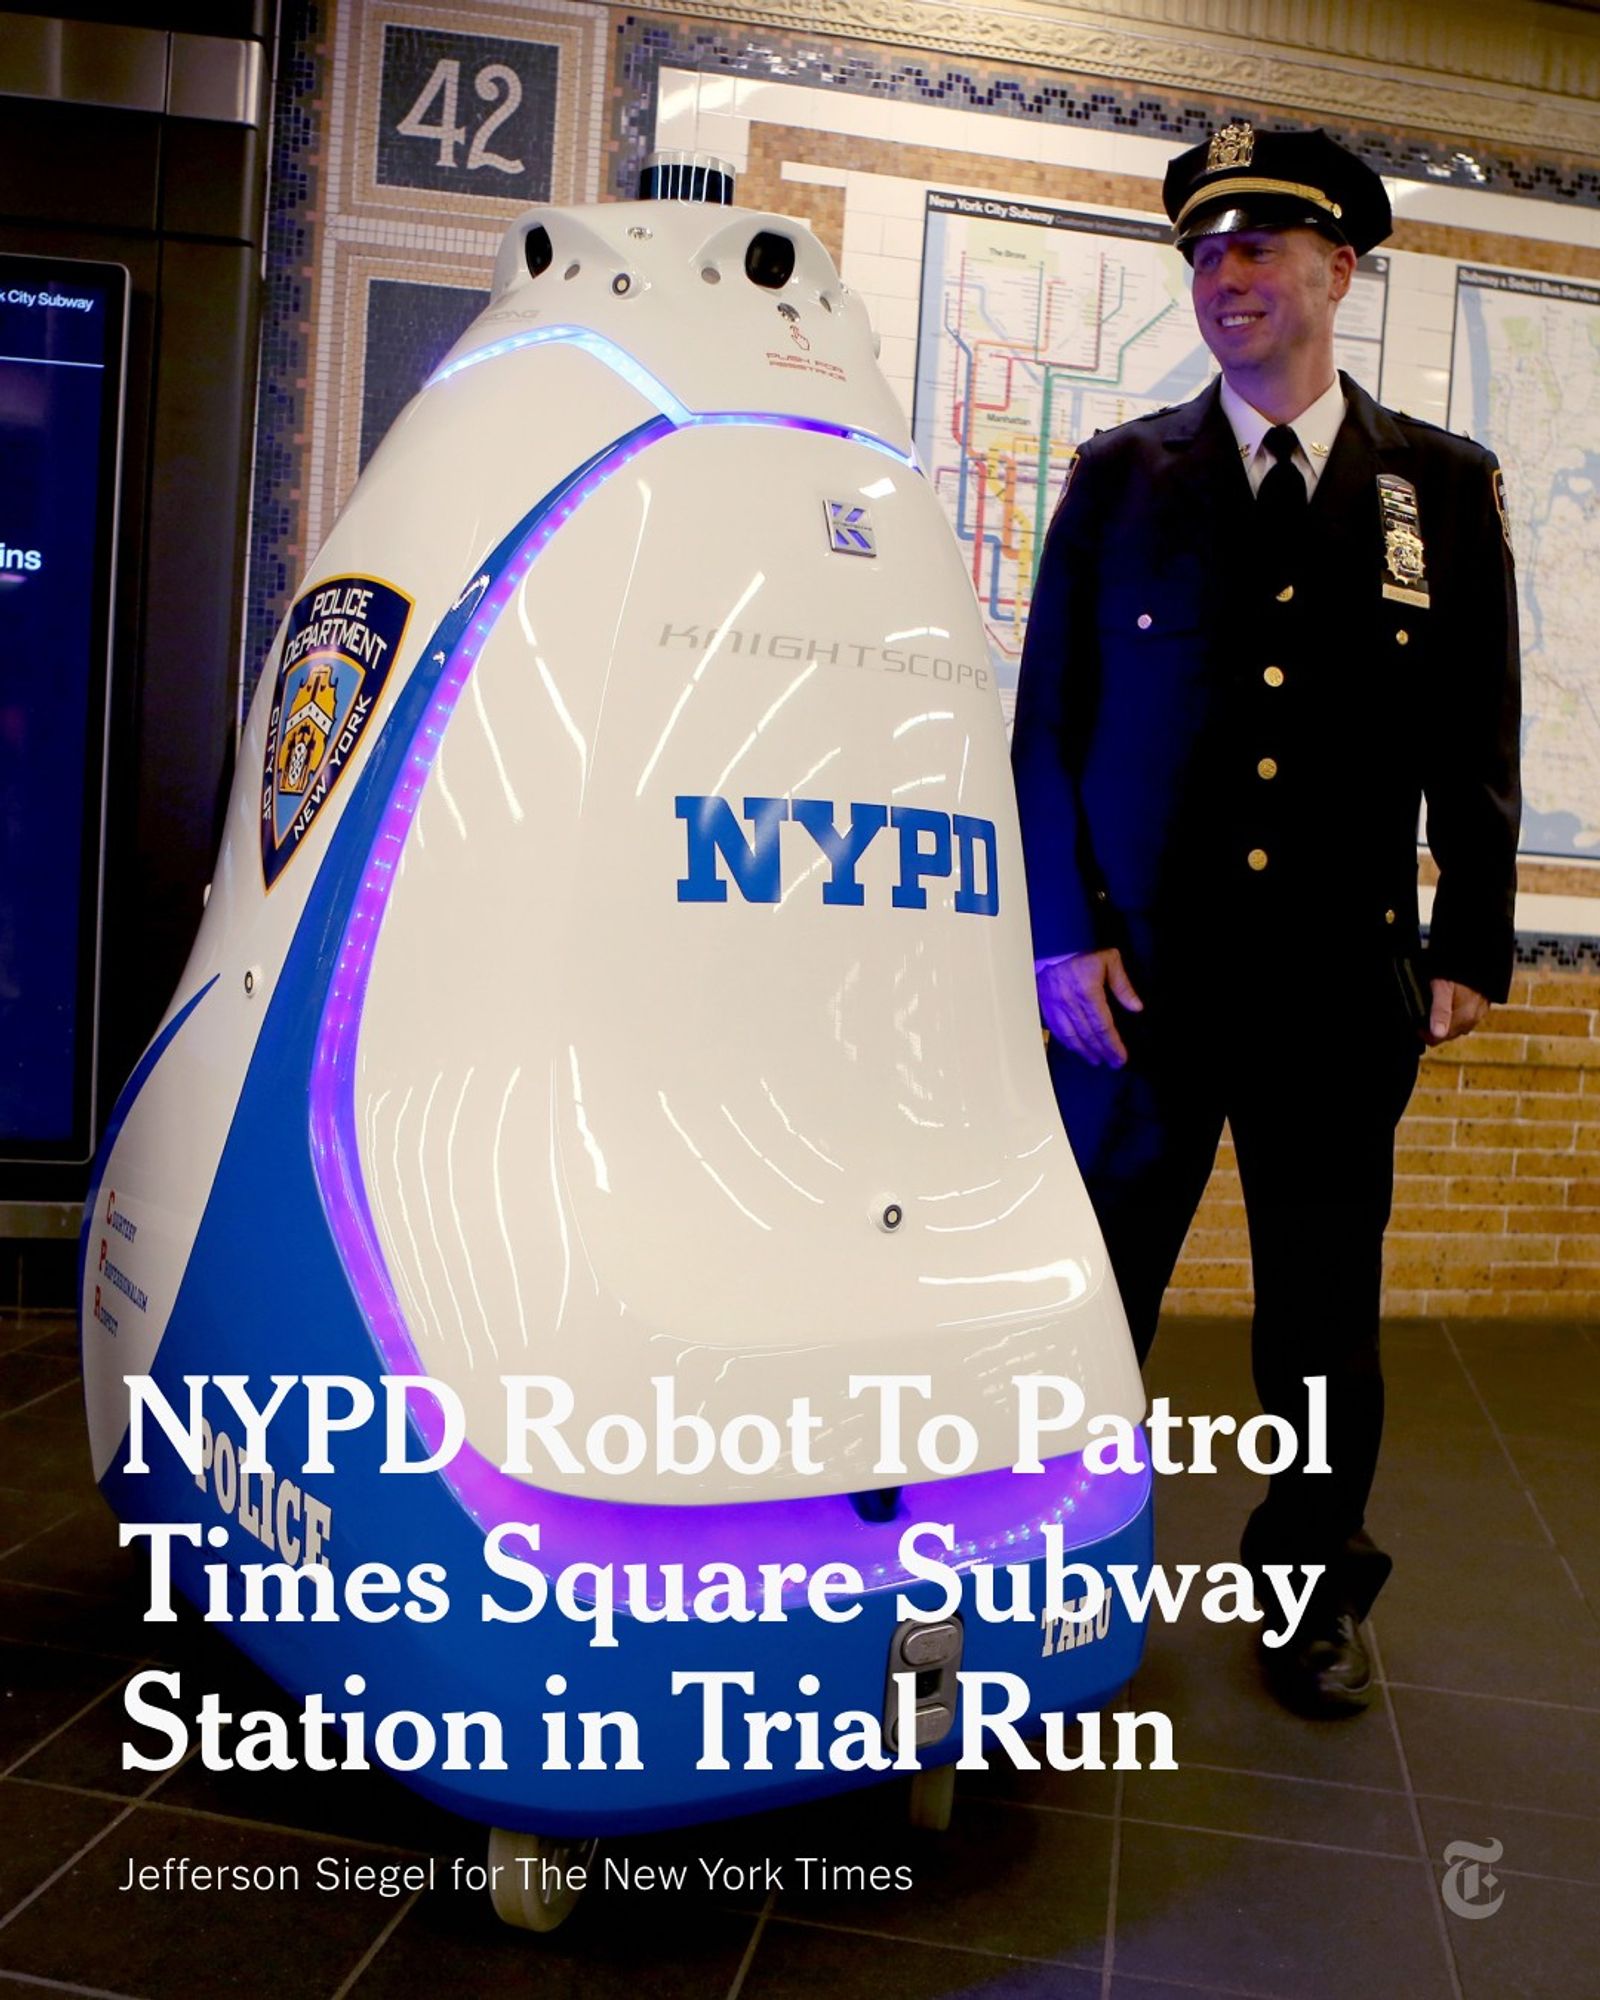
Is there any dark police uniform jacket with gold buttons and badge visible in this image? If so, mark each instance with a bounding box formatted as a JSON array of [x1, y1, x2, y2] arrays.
[[1012, 376, 1520, 1000]]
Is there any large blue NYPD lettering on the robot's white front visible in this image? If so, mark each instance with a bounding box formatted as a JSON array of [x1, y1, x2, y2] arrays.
[[676, 792, 1000, 916]]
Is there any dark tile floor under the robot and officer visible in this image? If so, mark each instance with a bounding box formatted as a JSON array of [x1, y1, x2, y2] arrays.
[[0, 1312, 1600, 2000]]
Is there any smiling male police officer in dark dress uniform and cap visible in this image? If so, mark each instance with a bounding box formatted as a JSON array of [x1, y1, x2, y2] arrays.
[[1014, 124, 1520, 1714]]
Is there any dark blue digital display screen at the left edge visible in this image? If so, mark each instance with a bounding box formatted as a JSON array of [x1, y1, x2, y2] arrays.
[[0, 254, 128, 1160]]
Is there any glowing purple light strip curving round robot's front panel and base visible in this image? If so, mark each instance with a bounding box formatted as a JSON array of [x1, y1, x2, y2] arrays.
[[310, 414, 1150, 1596]]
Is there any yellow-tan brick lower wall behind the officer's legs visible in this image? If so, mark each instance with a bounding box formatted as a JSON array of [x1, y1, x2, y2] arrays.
[[1168, 966, 1600, 1318]]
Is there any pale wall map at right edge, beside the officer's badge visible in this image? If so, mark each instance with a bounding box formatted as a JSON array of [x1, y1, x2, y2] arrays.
[[1450, 264, 1600, 856]]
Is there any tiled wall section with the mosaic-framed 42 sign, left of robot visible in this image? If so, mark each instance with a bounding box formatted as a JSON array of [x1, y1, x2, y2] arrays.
[[244, 0, 610, 680]]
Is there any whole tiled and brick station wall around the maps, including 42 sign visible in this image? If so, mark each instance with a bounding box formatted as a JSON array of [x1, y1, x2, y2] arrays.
[[246, 0, 1600, 1314]]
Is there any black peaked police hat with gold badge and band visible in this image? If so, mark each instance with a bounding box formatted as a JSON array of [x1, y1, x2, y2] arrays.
[[1162, 122, 1394, 262]]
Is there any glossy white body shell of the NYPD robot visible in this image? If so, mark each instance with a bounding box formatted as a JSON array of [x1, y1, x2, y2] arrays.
[[87, 204, 1140, 1500]]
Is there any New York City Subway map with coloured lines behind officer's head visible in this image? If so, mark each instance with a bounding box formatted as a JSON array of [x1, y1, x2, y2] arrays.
[[914, 190, 1388, 716]]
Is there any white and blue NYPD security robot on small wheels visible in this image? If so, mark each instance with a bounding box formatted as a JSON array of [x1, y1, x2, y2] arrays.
[[82, 148, 1150, 1928]]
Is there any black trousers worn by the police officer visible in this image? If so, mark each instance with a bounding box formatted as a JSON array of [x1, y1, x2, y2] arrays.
[[1050, 960, 1420, 1616]]
